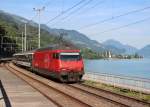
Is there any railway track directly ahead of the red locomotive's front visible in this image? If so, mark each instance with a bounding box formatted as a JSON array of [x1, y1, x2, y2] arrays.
[[70, 84, 150, 107]]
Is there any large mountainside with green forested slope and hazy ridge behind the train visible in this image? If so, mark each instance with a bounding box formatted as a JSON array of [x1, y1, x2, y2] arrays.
[[0, 10, 110, 59]]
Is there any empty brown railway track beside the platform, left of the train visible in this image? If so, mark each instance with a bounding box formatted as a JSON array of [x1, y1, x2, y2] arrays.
[[6, 65, 90, 107]]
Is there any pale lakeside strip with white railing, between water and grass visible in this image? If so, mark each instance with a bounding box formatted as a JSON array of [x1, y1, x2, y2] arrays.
[[83, 73, 150, 94]]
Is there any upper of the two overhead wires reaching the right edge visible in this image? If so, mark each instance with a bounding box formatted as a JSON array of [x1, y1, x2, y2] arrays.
[[79, 6, 150, 30]]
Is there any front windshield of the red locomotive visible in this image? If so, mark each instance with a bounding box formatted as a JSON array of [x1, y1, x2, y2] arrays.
[[60, 53, 81, 61]]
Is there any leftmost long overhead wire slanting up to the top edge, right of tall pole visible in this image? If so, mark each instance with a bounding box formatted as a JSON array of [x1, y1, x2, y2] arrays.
[[45, 0, 86, 24]]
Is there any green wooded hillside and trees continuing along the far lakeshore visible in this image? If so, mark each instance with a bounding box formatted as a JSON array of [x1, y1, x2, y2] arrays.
[[0, 11, 144, 59]]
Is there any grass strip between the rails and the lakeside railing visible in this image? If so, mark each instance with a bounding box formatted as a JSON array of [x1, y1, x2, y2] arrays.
[[83, 80, 150, 102]]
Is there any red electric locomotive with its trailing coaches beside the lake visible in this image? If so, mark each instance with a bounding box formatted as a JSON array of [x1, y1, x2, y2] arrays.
[[14, 46, 84, 82]]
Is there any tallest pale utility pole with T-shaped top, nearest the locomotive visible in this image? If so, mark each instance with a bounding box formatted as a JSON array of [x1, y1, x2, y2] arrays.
[[33, 7, 45, 48]]
